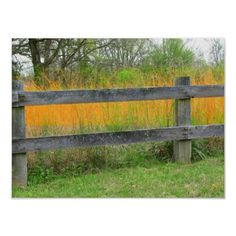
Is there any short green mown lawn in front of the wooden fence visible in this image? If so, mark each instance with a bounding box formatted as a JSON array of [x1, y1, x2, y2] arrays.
[[12, 156, 224, 198]]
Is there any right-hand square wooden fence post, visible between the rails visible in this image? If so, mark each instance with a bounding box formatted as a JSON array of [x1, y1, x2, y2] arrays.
[[174, 77, 192, 163]]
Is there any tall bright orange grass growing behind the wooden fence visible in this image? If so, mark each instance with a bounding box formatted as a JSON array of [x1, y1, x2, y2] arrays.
[[24, 69, 224, 137]]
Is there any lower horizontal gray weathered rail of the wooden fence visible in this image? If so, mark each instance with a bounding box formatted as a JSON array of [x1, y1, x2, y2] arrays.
[[12, 125, 224, 153]]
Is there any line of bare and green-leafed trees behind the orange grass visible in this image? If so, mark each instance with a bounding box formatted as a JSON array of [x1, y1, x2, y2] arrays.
[[12, 38, 224, 81]]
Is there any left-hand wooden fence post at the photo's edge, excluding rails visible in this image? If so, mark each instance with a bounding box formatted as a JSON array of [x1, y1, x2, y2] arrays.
[[12, 80, 27, 187]]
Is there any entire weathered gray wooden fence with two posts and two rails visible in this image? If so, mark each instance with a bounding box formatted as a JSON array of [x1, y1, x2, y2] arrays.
[[12, 77, 224, 186]]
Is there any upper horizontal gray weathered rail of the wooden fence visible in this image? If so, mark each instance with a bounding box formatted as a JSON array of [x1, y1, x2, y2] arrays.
[[12, 84, 224, 107]]
